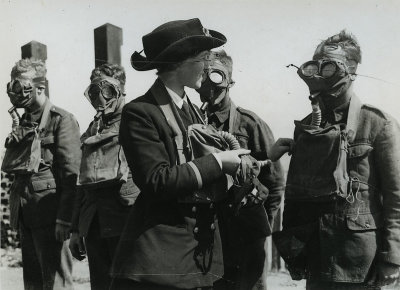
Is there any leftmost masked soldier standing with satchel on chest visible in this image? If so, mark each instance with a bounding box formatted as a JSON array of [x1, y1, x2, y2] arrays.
[[2, 59, 81, 290]]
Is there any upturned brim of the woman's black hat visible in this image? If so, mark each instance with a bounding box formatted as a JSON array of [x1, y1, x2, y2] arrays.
[[131, 30, 226, 71]]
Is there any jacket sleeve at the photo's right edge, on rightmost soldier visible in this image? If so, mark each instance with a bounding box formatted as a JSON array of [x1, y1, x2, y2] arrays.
[[374, 119, 400, 265]]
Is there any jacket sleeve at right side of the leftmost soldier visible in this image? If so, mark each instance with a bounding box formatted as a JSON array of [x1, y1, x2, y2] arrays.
[[54, 114, 81, 225]]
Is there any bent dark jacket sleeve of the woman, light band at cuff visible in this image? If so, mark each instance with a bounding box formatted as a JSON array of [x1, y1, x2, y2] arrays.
[[120, 103, 222, 199]]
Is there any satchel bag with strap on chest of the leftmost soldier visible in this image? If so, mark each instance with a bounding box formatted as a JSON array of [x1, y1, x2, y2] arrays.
[[1, 101, 51, 174]]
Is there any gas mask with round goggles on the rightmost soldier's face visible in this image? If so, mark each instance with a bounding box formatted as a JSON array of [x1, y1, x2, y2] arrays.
[[297, 59, 354, 98]]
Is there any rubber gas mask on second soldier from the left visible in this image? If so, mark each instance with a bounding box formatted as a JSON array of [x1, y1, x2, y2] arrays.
[[85, 76, 122, 116]]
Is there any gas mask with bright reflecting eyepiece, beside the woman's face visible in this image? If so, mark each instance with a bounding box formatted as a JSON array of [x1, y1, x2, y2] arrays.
[[196, 52, 234, 111]]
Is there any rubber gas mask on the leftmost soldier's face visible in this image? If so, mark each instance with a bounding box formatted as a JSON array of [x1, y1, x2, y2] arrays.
[[7, 77, 46, 108]]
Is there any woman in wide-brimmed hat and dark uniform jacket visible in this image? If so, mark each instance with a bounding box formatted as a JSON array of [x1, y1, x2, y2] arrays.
[[111, 19, 249, 290]]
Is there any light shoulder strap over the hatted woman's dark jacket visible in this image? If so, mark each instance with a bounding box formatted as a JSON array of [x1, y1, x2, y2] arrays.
[[150, 80, 186, 164]]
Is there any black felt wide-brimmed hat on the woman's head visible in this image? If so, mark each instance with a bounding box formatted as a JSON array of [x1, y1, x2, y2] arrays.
[[131, 18, 226, 71]]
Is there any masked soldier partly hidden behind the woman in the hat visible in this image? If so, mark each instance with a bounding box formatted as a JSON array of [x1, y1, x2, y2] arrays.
[[197, 50, 290, 289]]
